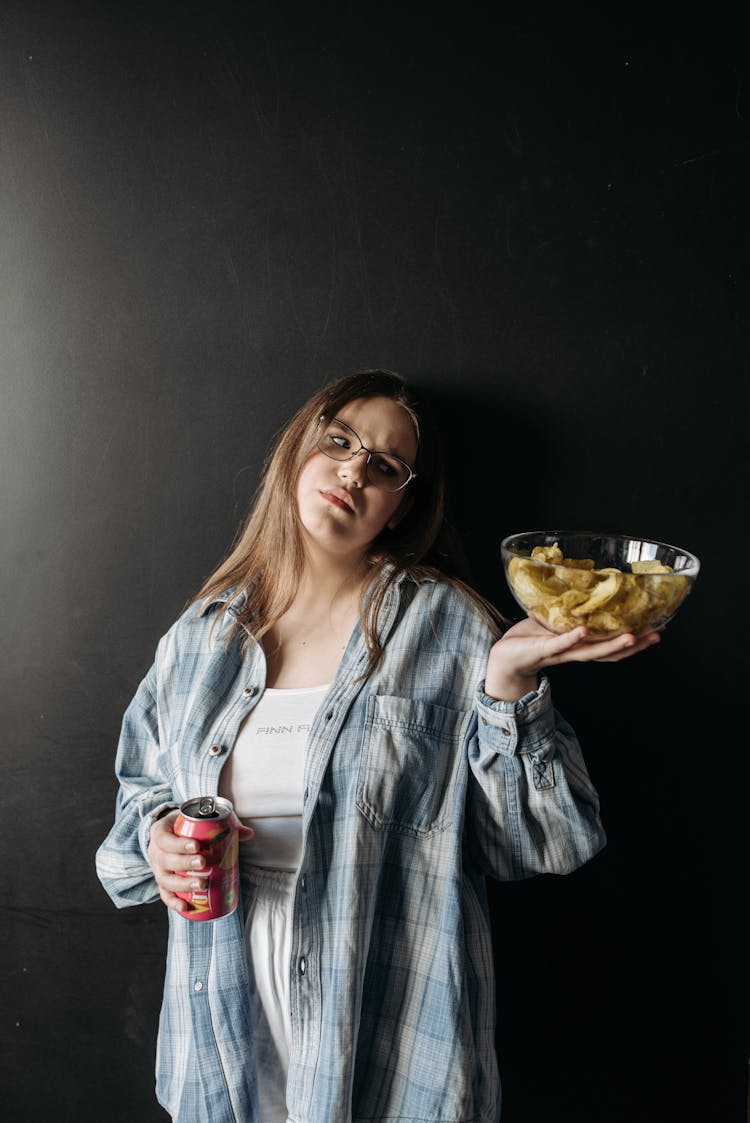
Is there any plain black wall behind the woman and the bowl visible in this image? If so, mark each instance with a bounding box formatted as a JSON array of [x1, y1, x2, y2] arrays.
[[0, 0, 750, 1123]]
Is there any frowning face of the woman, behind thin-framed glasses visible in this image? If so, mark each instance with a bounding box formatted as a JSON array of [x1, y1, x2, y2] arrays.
[[296, 398, 417, 570]]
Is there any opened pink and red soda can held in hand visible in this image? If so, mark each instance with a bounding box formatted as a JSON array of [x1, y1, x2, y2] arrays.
[[174, 795, 239, 920]]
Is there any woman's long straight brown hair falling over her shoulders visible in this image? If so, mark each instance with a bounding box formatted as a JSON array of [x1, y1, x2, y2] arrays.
[[194, 369, 504, 674]]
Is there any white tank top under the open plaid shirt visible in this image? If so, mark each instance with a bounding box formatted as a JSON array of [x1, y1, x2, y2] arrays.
[[219, 684, 330, 869]]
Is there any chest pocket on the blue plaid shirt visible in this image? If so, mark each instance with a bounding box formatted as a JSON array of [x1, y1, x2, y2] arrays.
[[357, 695, 472, 836]]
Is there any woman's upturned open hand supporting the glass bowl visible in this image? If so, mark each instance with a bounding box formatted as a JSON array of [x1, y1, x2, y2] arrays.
[[484, 618, 660, 702]]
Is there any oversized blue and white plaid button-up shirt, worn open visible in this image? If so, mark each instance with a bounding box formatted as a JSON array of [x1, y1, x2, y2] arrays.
[[97, 577, 604, 1123]]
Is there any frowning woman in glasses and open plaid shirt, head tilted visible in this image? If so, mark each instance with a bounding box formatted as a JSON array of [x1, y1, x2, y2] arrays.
[[98, 371, 658, 1123]]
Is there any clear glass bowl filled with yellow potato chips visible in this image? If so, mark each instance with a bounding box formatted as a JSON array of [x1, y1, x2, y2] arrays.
[[501, 530, 701, 639]]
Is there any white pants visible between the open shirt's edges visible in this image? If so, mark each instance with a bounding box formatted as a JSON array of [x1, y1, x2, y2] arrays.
[[241, 864, 295, 1123]]
